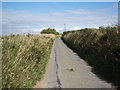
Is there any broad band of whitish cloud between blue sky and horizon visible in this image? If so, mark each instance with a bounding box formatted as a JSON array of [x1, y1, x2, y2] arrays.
[[2, 9, 118, 34]]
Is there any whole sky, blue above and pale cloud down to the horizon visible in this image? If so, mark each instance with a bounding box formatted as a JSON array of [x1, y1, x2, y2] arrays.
[[2, 2, 118, 35]]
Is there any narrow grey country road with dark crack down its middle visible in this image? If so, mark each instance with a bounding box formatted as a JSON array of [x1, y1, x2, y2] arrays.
[[35, 38, 111, 88]]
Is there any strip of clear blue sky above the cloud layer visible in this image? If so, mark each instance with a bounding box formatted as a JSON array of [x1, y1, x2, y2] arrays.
[[3, 2, 115, 13]]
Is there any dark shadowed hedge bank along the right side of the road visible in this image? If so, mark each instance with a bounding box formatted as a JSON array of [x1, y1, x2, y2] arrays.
[[62, 26, 120, 87]]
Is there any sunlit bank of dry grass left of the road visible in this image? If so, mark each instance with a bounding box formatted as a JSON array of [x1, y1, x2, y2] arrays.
[[2, 35, 56, 88]]
